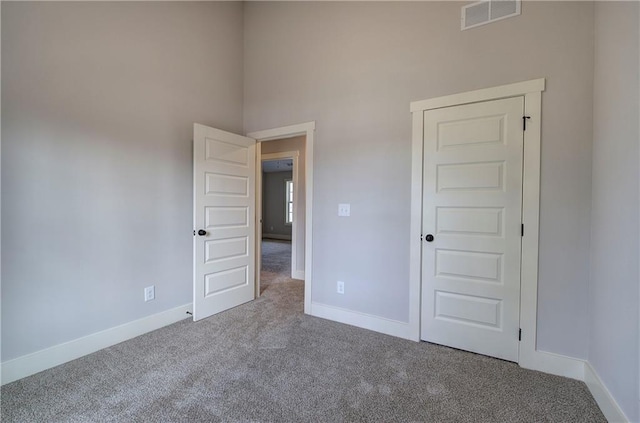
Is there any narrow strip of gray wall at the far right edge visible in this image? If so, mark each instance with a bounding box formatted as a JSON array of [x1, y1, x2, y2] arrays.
[[589, 2, 640, 422]]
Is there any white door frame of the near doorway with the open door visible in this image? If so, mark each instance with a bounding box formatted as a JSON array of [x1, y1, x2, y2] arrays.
[[247, 121, 316, 314]]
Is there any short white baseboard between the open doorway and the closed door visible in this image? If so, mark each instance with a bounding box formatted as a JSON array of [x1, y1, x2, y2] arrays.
[[311, 302, 411, 339]]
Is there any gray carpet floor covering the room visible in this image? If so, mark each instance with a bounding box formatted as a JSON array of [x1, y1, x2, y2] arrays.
[[1, 240, 606, 422]]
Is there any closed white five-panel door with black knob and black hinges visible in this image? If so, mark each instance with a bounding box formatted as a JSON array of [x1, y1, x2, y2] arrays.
[[421, 97, 524, 361]]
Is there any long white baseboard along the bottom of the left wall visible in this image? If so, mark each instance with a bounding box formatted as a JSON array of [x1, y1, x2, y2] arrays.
[[1, 304, 193, 385]]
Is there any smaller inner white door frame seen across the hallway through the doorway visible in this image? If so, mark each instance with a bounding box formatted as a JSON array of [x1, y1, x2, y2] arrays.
[[256, 151, 304, 284]]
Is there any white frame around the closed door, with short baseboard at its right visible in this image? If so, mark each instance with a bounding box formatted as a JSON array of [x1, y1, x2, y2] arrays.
[[409, 78, 581, 378]]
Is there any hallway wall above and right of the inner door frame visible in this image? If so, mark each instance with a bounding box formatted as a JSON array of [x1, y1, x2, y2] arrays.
[[260, 137, 307, 272]]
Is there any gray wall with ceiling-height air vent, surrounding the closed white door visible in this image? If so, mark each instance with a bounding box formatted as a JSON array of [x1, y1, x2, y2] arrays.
[[244, 2, 593, 358]]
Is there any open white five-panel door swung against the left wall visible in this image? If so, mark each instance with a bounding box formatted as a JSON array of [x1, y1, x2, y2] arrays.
[[193, 124, 256, 320]]
